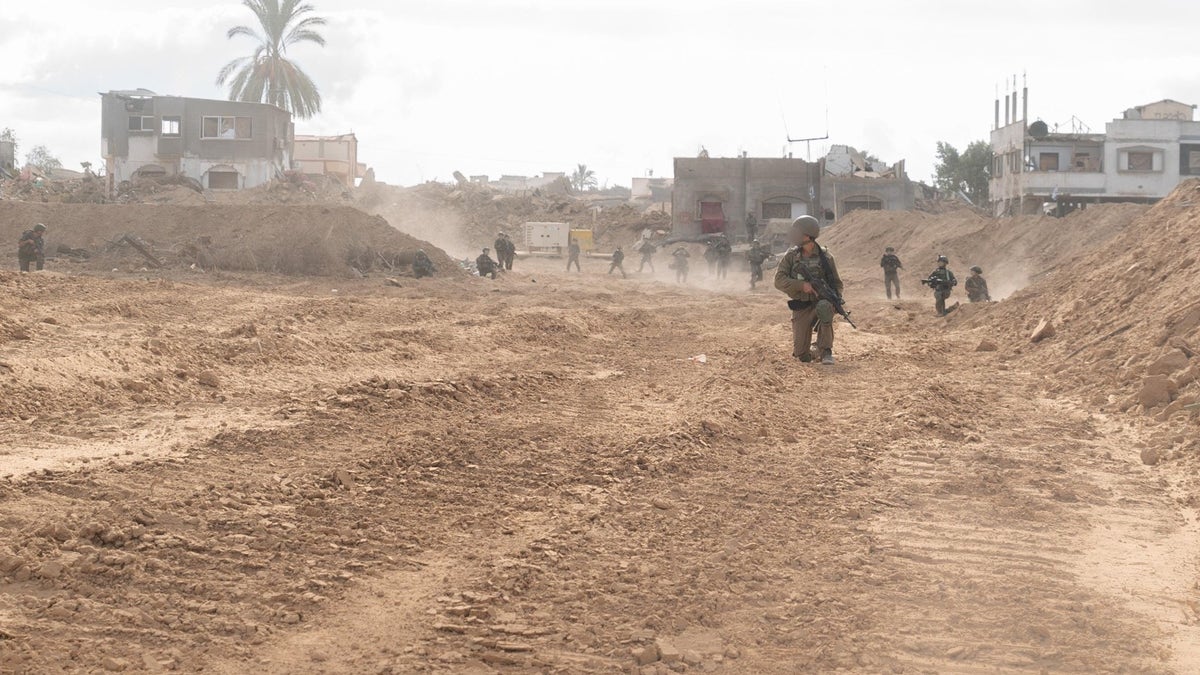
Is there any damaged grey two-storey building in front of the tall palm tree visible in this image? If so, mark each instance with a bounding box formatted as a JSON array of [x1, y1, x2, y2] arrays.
[[101, 89, 294, 192]]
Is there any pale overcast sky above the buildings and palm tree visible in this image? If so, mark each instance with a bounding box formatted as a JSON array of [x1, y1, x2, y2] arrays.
[[0, 0, 1200, 185]]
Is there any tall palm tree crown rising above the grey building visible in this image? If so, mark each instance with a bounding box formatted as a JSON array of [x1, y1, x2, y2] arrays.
[[217, 0, 325, 119]]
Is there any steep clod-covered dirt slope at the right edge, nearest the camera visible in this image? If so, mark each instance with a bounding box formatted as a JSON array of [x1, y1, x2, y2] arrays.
[[954, 180, 1200, 426]]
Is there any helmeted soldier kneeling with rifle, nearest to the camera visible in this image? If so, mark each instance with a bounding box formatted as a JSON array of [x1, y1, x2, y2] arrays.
[[775, 216, 844, 365]]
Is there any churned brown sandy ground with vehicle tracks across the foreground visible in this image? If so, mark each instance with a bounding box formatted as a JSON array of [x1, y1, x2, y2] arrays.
[[0, 254, 1200, 674]]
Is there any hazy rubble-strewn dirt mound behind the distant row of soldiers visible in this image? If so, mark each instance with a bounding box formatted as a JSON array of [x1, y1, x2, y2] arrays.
[[355, 183, 671, 256]]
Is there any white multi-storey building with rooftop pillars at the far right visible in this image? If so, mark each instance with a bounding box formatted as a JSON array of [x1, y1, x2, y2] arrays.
[[989, 90, 1200, 215]]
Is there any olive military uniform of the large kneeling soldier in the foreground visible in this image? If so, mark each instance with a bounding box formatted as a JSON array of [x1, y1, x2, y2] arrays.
[[775, 244, 845, 363]]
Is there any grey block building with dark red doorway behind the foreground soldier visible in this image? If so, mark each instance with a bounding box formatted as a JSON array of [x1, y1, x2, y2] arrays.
[[671, 156, 824, 238]]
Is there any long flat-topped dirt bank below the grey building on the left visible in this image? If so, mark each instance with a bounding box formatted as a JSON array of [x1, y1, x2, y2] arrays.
[[0, 201, 464, 276]]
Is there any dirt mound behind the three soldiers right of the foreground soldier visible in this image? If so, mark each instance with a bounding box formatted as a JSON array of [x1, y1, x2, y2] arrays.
[[824, 204, 1146, 298]]
